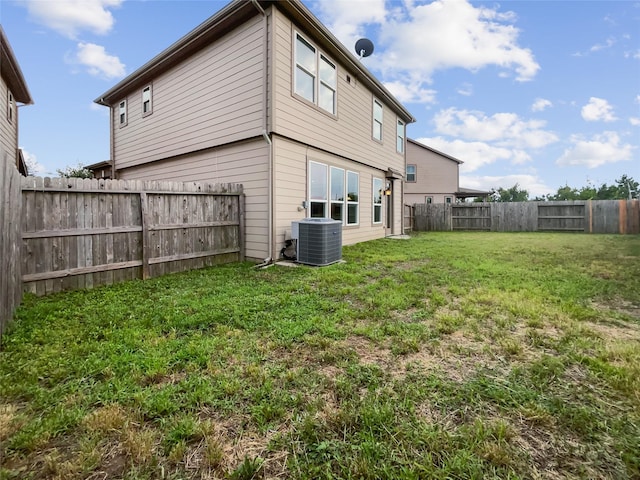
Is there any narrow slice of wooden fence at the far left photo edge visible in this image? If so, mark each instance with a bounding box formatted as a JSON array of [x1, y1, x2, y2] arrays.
[[0, 147, 22, 341]]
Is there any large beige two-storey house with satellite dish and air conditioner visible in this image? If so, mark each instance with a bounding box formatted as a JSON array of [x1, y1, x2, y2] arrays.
[[95, 0, 414, 260]]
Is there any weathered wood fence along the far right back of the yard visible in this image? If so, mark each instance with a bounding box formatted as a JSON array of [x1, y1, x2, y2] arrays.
[[413, 200, 640, 234]]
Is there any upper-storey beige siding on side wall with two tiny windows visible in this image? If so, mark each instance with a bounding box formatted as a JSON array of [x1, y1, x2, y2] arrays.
[[112, 16, 265, 169]]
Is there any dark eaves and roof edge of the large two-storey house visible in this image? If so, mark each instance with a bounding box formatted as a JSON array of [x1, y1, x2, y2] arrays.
[[94, 0, 415, 123]]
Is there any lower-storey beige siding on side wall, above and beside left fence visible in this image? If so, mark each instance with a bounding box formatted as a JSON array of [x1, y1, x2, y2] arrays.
[[118, 138, 269, 260]]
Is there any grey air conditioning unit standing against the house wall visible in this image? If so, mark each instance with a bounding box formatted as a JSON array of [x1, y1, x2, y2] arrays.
[[291, 218, 342, 266]]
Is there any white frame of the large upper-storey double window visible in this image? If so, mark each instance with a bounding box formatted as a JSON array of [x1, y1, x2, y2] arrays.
[[292, 32, 338, 116]]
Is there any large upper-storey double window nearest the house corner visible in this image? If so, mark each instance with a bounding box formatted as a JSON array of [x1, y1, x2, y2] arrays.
[[294, 33, 338, 115]]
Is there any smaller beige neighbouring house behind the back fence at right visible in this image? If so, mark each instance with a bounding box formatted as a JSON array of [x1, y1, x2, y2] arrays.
[[404, 138, 491, 205]]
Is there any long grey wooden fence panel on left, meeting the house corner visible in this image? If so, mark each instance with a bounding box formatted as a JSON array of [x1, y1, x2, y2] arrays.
[[21, 177, 244, 295]]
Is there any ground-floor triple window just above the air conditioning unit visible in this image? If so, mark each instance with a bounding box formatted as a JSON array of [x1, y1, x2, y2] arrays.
[[309, 162, 360, 225]]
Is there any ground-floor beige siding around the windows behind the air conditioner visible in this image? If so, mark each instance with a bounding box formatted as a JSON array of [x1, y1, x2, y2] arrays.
[[273, 137, 392, 255]]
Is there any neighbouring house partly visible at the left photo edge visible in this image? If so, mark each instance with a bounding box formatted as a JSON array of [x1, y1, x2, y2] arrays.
[[0, 26, 33, 176]]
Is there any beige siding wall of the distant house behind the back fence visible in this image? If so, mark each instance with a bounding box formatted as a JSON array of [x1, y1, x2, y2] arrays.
[[404, 142, 459, 205]]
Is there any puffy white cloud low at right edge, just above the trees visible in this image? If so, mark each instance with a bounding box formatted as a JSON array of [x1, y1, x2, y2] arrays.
[[556, 132, 635, 168]]
